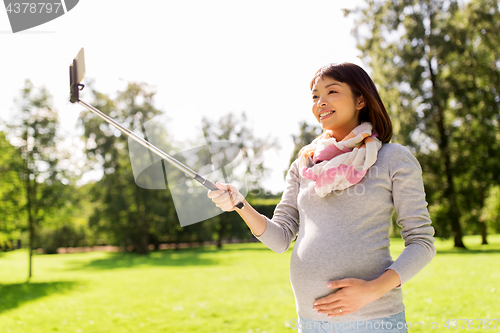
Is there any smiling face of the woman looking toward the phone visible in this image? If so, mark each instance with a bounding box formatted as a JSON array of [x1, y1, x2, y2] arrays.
[[312, 77, 365, 141]]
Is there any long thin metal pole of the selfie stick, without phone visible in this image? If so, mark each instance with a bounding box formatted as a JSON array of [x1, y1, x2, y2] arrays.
[[76, 98, 244, 209]]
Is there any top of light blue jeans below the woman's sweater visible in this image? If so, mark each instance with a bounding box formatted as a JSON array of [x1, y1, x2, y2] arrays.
[[298, 311, 408, 333]]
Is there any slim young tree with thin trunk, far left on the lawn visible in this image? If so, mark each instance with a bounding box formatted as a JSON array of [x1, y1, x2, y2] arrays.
[[9, 80, 60, 279]]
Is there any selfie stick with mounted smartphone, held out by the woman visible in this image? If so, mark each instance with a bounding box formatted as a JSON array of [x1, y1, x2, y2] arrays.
[[69, 48, 244, 209]]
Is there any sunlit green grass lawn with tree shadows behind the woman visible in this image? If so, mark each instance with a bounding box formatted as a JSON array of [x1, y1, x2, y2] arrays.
[[0, 235, 500, 333]]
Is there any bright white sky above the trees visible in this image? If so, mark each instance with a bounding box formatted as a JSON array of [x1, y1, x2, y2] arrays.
[[0, 0, 368, 193]]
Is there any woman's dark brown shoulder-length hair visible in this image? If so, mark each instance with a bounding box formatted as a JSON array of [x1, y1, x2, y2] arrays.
[[311, 62, 392, 143]]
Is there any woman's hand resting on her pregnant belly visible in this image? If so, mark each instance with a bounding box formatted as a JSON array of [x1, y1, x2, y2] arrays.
[[313, 278, 381, 317]]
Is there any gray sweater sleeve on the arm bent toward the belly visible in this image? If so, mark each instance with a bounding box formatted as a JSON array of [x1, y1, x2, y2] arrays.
[[387, 146, 436, 284]]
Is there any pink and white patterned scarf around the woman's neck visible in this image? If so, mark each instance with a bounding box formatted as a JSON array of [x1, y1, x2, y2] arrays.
[[299, 122, 382, 197]]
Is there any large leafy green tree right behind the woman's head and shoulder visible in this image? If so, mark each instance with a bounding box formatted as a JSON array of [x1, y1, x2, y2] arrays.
[[346, 0, 499, 247]]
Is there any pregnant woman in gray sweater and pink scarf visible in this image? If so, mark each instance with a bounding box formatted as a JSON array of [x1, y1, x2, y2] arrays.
[[208, 63, 436, 333]]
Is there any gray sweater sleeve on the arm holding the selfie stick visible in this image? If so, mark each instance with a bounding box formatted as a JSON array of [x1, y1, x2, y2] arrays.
[[250, 160, 300, 253]]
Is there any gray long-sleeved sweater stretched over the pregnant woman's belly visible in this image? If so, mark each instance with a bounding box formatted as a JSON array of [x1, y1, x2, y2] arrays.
[[252, 144, 436, 321]]
